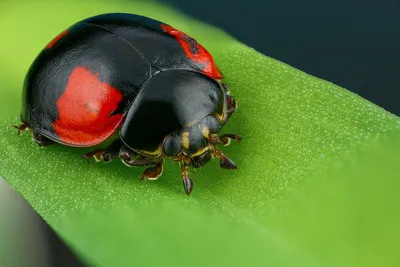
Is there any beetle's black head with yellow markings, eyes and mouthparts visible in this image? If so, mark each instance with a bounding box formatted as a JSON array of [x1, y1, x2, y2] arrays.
[[162, 115, 241, 169]]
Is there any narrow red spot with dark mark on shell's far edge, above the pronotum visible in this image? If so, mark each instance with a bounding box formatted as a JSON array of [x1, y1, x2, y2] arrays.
[[161, 24, 223, 79]]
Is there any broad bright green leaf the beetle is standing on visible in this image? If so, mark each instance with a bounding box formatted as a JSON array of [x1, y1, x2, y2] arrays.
[[0, 1, 400, 267]]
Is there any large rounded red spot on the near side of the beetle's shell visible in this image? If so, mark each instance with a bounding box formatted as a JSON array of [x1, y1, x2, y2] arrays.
[[53, 67, 123, 146]]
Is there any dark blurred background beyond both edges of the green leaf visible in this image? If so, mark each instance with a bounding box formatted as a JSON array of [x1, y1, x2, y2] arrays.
[[0, 0, 400, 267]]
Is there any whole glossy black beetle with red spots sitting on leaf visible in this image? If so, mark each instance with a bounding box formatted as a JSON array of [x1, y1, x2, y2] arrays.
[[13, 13, 241, 195]]
